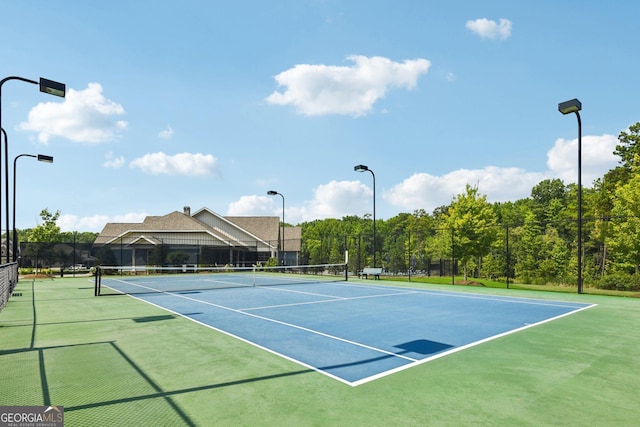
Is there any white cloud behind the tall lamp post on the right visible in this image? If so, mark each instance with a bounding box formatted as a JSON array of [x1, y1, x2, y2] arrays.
[[547, 135, 620, 186]]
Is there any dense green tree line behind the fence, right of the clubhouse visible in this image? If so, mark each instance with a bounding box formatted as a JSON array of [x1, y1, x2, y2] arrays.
[[300, 123, 640, 290]]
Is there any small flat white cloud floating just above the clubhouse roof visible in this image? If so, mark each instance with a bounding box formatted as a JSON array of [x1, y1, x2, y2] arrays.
[[129, 153, 220, 177]]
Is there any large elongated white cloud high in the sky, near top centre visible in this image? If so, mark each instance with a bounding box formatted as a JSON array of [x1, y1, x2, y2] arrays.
[[266, 55, 431, 116]]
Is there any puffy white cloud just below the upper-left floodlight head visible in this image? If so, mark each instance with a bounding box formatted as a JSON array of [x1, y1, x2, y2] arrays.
[[18, 83, 127, 144]]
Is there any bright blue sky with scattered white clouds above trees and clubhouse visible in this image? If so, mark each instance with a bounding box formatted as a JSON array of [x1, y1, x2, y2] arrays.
[[0, 0, 640, 231]]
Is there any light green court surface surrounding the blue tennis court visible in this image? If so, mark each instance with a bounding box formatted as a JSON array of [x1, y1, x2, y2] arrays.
[[0, 278, 640, 426]]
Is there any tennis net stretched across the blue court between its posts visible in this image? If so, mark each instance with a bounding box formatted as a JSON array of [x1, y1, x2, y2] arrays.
[[95, 264, 348, 296]]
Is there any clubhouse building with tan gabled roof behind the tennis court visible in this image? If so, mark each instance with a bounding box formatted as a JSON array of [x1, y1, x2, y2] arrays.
[[93, 206, 302, 267]]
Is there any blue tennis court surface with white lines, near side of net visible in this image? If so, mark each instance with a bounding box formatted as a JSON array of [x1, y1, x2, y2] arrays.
[[101, 281, 591, 386]]
